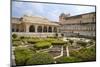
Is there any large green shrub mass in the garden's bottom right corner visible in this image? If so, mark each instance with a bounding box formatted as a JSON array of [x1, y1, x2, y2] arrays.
[[70, 47, 96, 61]]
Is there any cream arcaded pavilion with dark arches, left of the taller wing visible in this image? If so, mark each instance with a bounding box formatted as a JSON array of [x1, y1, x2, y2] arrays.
[[12, 15, 60, 37]]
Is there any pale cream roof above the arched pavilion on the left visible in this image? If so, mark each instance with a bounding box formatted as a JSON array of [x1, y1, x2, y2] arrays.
[[12, 15, 59, 26]]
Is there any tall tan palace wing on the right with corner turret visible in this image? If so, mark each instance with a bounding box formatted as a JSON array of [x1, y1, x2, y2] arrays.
[[59, 12, 96, 37]]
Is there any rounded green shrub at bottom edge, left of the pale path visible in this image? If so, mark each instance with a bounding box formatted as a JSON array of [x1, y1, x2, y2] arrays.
[[27, 52, 54, 65]]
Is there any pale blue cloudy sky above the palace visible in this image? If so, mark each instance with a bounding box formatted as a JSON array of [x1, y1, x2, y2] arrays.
[[12, 1, 95, 21]]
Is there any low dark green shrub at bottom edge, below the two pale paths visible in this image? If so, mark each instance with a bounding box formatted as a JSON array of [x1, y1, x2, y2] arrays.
[[56, 56, 81, 63]]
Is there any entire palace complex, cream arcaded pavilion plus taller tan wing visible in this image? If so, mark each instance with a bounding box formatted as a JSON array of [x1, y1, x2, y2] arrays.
[[11, 12, 96, 37]]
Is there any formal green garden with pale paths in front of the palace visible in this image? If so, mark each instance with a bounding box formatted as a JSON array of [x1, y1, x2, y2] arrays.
[[12, 34, 96, 66]]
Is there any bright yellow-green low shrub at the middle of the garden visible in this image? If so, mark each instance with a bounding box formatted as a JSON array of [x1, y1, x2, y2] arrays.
[[34, 41, 51, 49]]
